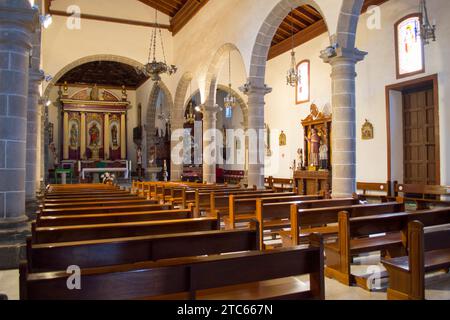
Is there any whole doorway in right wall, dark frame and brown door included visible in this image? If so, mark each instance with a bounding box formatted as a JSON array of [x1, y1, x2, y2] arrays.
[[386, 75, 440, 185]]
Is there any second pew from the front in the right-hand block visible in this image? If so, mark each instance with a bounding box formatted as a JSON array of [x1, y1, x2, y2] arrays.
[[325, 208, 450, 290]]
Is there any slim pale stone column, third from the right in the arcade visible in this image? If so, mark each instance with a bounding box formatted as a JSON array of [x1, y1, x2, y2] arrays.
[[202, 105, 219, 183]]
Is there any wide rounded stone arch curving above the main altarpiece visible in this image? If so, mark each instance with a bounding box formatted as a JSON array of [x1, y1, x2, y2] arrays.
[[43, 54, 143, 101]]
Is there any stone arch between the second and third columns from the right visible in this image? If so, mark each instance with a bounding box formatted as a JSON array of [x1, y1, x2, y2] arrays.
[[205, 43, 246, 105]]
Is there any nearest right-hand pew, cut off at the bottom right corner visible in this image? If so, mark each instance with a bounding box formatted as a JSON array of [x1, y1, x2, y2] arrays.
[[382, 221, 450, 300]]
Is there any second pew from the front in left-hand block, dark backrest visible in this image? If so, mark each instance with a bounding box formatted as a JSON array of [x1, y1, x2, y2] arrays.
[[27, 229, 259, 273]]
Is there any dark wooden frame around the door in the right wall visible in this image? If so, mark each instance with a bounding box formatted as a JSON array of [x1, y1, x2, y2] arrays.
[[386, 74, 441, 184]]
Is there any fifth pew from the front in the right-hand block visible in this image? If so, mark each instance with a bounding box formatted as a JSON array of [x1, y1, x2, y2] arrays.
[[227, 193, 322, 229]]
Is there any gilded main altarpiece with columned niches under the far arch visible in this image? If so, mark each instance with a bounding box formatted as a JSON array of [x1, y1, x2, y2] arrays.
[[59, 85, 130, 162]]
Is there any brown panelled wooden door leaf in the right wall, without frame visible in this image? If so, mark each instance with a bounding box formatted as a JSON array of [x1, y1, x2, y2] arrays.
[[403, 88, 439, 185]]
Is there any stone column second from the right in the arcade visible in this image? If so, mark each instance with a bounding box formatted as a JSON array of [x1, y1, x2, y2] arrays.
[[239, 82, 272, 189]]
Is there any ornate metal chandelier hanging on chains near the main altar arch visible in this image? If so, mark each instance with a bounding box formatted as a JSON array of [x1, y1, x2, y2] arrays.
[[136, 10, 177, 82]]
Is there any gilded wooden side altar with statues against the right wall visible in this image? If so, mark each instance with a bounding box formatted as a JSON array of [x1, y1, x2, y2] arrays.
[[294, 104, 332, 195]]
